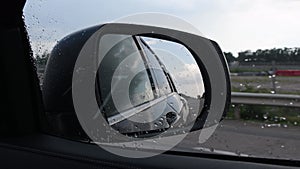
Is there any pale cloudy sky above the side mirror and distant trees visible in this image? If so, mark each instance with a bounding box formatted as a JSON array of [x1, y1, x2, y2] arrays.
[[24, 0, 300, 56]]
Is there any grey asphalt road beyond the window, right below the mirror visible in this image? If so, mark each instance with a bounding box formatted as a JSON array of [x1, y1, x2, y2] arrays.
[[174, 120, 300, 160]]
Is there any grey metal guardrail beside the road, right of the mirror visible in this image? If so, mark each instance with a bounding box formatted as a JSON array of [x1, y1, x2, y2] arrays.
[[231, 92, 300, 108]]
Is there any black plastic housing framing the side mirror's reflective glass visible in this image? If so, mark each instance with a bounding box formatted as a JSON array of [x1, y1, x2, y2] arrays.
[[42, 23, 231, 138]]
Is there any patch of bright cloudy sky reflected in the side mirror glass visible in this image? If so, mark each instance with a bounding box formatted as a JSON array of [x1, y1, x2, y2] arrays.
[[142, 37, 205, 98]]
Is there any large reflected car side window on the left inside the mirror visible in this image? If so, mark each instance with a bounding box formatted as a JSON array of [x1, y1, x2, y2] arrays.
[[98, 35, 154, 116]]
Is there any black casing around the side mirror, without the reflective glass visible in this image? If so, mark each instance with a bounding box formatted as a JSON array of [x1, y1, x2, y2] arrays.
[[43, 23, 231, 138]]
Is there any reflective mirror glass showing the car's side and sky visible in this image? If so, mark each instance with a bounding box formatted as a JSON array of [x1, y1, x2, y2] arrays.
[[96, 34, 205, 137]]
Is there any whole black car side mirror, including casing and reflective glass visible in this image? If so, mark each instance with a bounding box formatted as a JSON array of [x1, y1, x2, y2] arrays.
[[43, 23, 231, 138]]
